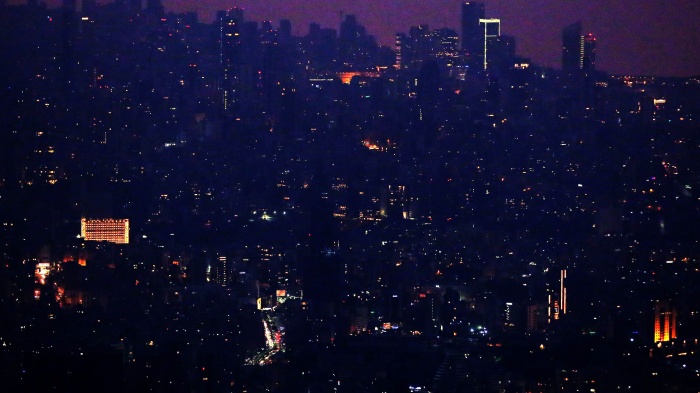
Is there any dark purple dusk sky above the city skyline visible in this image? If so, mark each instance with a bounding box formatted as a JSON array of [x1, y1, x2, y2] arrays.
[[43, 0, 700, 76]]
